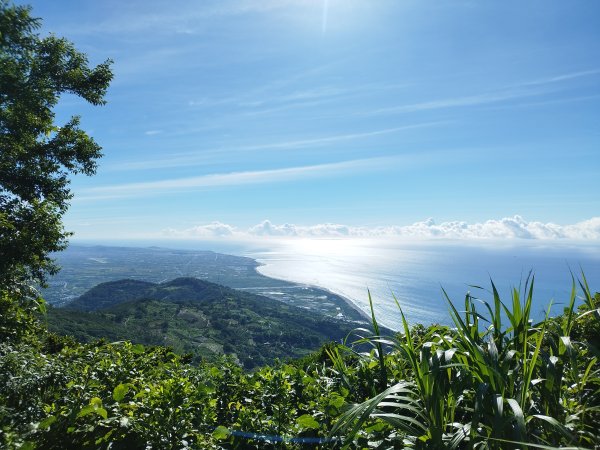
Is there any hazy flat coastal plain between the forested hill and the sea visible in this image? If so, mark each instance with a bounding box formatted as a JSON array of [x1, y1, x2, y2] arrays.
[[42, 245, 365, 321]]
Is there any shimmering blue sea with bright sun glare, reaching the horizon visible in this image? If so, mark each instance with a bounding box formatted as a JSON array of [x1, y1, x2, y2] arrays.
[[74, 238, 600, 329]]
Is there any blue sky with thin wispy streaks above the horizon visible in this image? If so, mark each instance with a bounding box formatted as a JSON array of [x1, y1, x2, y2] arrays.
[[19, 0, 600, 239]]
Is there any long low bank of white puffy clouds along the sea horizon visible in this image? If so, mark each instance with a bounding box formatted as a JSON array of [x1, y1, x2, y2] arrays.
[[165, 215, 600, 240]]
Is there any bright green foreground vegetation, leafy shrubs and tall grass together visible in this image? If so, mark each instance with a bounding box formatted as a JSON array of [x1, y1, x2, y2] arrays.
[[0, 274, 600, 449]]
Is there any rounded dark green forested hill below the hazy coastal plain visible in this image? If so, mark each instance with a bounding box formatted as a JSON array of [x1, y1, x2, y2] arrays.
[[47, 278, 360, 368]]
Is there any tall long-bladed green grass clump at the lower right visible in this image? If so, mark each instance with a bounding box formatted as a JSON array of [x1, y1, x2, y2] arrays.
[[331, 275, 600, 449]]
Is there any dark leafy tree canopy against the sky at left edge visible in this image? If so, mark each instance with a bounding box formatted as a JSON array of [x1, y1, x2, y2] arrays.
[[0, 0, 112, 288]]
